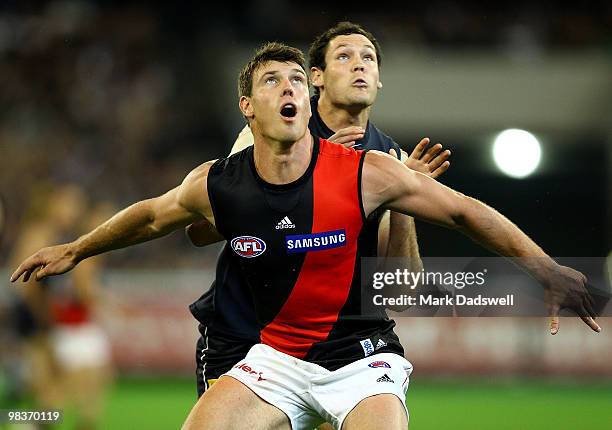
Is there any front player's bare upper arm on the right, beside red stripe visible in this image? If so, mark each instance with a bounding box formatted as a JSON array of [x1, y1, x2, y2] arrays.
[[362, 151, 464, 228]]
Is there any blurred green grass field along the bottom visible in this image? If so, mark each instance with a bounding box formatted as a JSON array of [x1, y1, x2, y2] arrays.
[[14, 378, 612, 430]]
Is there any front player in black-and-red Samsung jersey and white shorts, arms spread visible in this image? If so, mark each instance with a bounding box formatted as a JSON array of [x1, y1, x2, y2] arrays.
[[11, 43, 601, 430]]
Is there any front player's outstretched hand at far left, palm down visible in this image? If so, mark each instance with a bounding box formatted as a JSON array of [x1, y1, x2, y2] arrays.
[[11, 244, 77, 282]]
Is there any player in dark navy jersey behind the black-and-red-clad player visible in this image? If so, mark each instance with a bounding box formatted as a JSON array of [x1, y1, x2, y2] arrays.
[[187, 22, 450, 404]]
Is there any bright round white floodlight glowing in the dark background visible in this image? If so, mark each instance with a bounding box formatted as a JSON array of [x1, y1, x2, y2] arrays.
[[493, 128, 542, 178]]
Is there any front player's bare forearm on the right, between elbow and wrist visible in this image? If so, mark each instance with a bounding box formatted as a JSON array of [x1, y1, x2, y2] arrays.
[[454, 196, 557, 282]]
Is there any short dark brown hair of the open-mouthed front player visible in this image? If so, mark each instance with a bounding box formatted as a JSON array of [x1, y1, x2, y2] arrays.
[[238, 42, 308, 97]]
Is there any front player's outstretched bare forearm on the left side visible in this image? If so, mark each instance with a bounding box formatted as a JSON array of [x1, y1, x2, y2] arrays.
[[70, 199, 173, 261]]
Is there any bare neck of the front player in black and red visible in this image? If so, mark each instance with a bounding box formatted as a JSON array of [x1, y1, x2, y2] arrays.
[[253, 132, 313, 185]]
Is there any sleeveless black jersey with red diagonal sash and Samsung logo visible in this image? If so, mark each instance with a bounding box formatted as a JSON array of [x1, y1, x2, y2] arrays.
[[208, 138, 403, 369]]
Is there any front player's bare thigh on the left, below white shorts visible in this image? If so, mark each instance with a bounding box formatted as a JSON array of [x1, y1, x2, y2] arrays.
[[183, 376, 291, 430]]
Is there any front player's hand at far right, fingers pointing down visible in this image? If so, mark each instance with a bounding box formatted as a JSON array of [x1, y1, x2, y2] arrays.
[[544, 266, 601, 334]]
